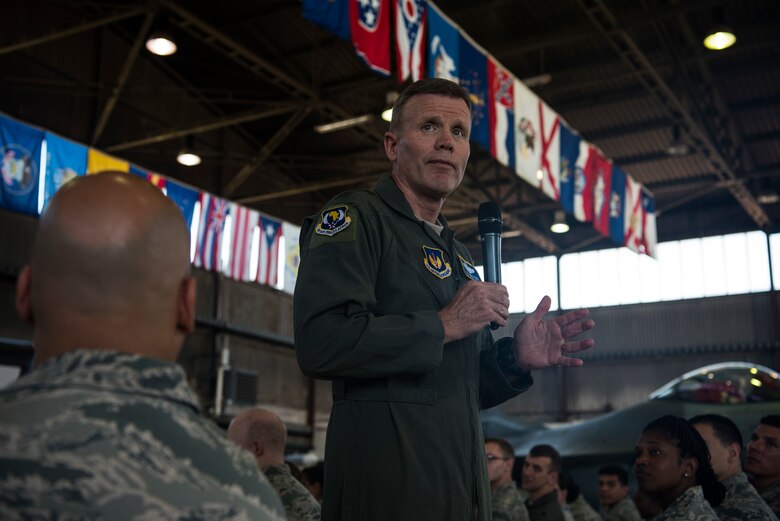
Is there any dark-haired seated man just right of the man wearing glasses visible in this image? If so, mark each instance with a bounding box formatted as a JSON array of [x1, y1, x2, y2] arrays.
[[522, 445, 565, 521]]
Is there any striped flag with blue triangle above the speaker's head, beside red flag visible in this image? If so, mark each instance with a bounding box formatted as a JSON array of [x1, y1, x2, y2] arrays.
[[395, 0, 425, 83]]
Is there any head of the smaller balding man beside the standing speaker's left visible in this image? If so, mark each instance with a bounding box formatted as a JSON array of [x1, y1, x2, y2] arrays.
[[228, 409, 287, 469]]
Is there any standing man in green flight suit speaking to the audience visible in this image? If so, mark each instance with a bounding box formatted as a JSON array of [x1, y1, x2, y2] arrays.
[[294, 79, 593, 521]]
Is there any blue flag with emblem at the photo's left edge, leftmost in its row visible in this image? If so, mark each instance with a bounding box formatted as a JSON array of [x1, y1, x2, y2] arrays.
[[0, 115, 43, 215]]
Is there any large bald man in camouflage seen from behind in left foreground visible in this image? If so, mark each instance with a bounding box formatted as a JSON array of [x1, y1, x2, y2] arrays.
[[0, 173, 284, 520]]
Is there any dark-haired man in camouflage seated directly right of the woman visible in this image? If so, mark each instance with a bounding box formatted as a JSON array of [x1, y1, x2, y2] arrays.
[[689, 414, 777, 521]]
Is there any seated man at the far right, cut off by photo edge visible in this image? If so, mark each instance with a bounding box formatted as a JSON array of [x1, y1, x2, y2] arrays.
[[746, 414, 780, 517]]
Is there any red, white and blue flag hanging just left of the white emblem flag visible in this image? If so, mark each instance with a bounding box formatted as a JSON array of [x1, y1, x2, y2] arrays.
[[488, 58, 515, 170]]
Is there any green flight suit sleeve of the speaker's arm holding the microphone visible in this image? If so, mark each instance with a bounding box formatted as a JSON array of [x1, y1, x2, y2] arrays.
[[294, 204, 444, 379]]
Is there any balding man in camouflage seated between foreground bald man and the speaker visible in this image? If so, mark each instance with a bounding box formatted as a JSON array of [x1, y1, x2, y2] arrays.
[[228, 409, 320, 521]]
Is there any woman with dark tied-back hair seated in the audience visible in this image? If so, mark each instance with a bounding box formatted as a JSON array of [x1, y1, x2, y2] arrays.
[[634, 416, 726, 521]]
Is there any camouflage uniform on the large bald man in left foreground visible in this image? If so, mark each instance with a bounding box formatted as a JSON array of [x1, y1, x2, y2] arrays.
[[0, 350, 284, 520]]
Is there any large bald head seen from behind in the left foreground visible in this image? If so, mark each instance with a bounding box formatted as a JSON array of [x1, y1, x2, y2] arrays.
[[17, 172, 195, 362]]
